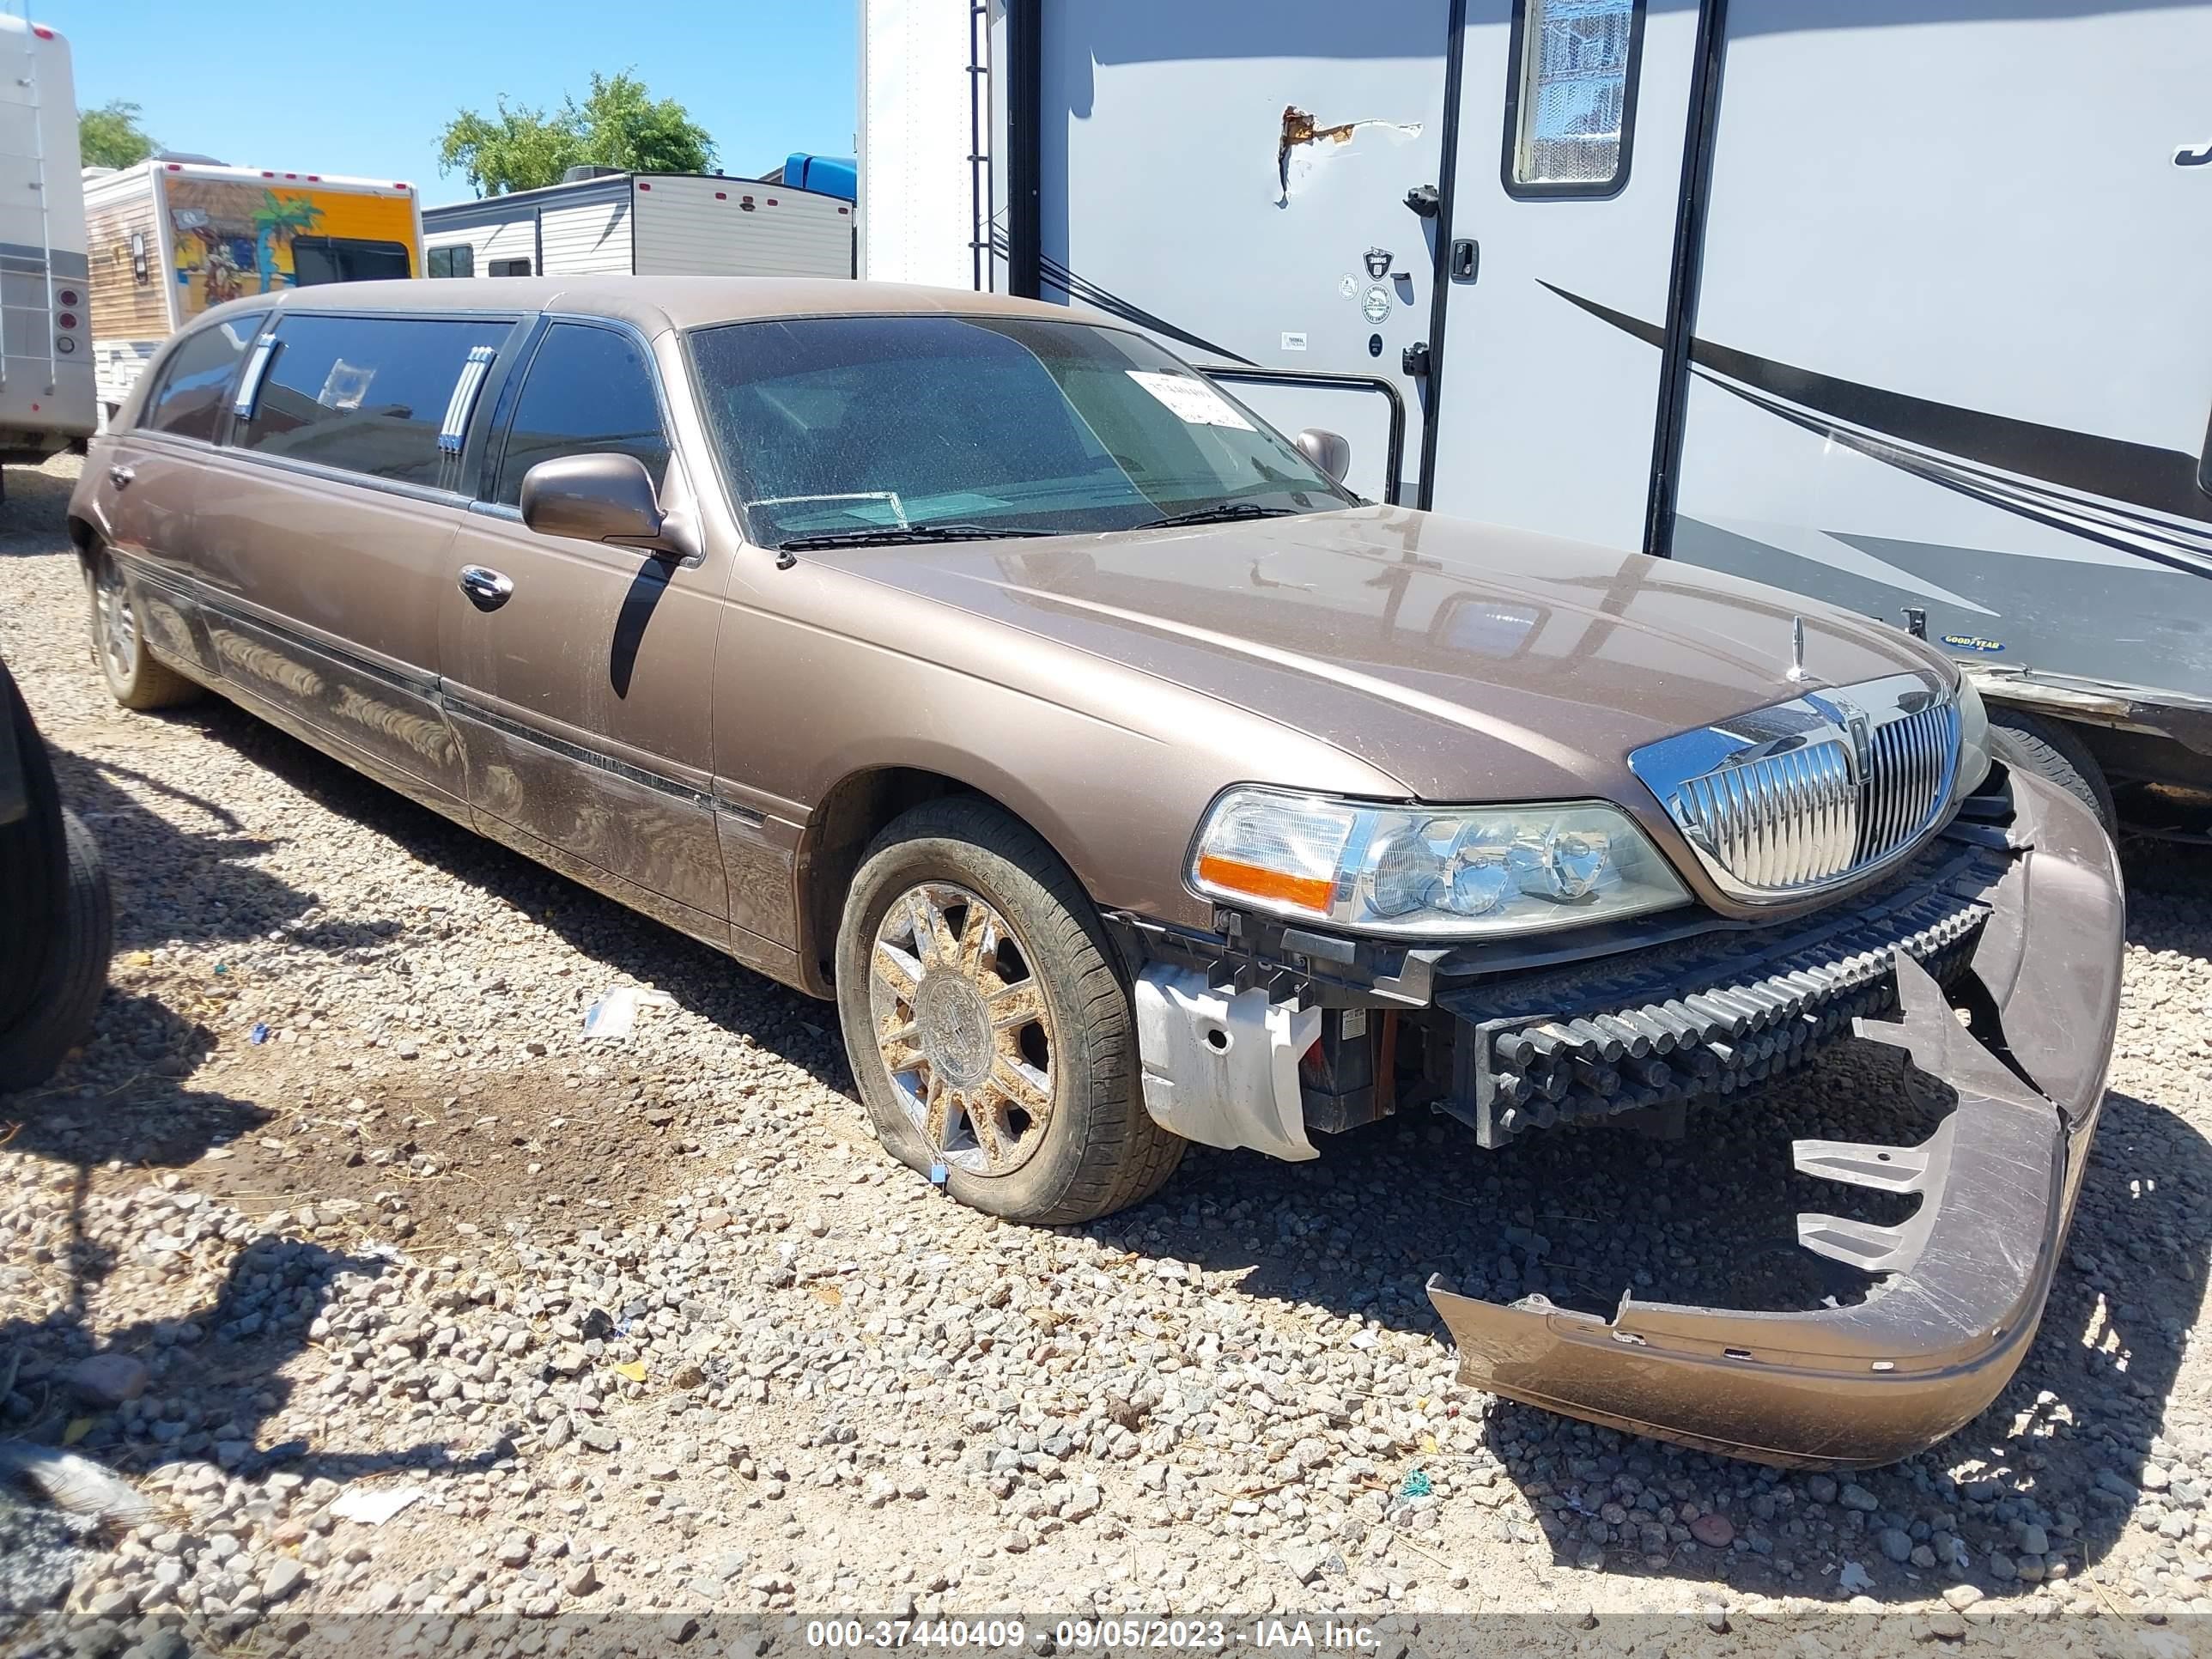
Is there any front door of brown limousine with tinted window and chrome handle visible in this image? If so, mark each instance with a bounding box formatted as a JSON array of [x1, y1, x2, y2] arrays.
[[438, 319, 728, 945]]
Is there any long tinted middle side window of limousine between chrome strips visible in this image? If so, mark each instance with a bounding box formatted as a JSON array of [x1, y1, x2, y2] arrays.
[[239, 316, 511, 484]]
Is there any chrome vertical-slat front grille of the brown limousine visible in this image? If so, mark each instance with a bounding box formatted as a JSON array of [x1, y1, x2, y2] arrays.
[[1628, 675, 1958, 898]]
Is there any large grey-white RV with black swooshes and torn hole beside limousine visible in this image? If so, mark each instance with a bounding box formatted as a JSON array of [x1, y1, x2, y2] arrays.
[[860, 0, 2212, 805]]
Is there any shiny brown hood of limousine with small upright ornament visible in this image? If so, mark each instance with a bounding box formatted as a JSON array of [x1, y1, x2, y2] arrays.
[[810, 507, 1951, 801]]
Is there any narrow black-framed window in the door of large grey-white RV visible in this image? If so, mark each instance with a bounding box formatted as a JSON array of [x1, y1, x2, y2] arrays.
[[1506, 0, 1644, 197]]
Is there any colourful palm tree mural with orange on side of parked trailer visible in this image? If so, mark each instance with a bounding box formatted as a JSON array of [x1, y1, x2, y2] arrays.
[[168, 179, 414, 319]]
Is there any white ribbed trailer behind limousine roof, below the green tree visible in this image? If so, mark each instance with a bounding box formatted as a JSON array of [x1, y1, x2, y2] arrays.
[[422, 173, 854, 276]]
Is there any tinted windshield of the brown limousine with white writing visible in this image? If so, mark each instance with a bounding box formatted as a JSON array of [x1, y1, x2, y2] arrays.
[[692, 314, 1356, 546]]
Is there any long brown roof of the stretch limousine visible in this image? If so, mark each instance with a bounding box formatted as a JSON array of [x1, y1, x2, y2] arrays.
[[208, 276, 1068, 334]]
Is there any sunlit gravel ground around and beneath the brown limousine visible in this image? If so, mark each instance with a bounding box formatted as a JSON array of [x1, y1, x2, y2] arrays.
[[0, 460, 2212, 1652]]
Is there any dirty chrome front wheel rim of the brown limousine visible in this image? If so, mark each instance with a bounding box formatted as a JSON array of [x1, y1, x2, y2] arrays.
[[867, 883, 1060, 1175]]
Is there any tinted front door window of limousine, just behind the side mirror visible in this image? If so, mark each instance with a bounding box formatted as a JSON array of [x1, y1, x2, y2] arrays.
[[493, 323, 668, 504]]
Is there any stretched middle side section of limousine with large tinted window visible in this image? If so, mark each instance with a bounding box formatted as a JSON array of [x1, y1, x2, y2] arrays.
[[197, 310, 515, 817]]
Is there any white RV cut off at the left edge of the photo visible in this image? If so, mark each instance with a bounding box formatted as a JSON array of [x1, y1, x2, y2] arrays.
[[0, 13, 95, 473]]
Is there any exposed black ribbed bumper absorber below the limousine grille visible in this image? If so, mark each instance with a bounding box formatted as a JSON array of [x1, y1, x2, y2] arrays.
[[1436, 852, 2004, 1146]]
